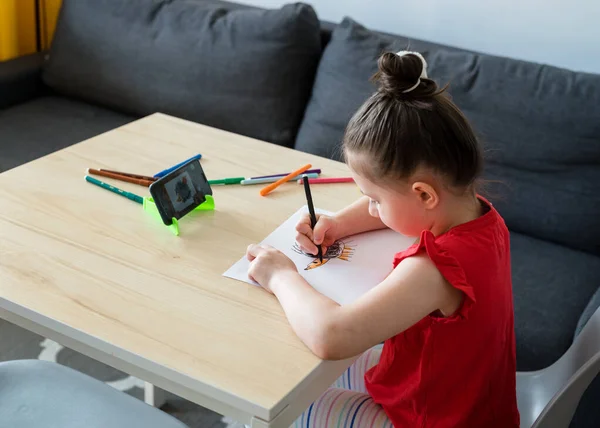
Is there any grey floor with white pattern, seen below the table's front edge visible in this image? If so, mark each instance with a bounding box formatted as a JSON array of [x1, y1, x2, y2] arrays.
[[0, 319, 243, 428]]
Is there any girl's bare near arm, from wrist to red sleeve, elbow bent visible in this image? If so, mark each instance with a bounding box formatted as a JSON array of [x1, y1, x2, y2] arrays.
[[269, 255, 463, 360]]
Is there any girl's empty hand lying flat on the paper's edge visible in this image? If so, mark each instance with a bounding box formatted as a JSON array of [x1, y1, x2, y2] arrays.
[[246, 244, 298, 293]]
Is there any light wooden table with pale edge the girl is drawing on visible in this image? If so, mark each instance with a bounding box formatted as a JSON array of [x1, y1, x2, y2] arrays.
[[0, 114, 359, 427]]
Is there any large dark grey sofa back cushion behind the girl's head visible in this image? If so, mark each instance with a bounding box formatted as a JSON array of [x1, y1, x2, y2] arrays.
[[296, 18, 600, 255]]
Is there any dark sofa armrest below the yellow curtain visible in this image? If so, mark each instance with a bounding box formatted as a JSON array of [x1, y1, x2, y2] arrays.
[[0, 52, 46, 109]]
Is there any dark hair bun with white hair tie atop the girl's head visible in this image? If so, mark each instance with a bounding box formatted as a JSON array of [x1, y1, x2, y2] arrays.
[[375, 51, 437, 98]]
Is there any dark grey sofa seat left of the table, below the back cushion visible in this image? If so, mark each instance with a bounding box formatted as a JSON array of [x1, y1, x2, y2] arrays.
[[0, 96, 134, 172]]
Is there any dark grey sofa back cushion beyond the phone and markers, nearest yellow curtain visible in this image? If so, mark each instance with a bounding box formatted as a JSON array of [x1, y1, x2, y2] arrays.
[[43, 0, 321, 146]]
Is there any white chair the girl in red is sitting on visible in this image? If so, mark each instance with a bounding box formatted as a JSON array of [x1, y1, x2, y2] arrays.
[[517, 308, 600, 428]]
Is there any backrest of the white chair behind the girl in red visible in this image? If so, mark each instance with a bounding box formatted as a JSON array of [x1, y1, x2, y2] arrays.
[[532, 308, 600, 428]]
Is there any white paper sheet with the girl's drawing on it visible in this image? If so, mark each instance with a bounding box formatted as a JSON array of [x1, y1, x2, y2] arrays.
[[223, 206, 415, 304]]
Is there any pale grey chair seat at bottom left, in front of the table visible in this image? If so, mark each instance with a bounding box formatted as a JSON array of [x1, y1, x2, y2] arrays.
[[0, 360, 187, 428]]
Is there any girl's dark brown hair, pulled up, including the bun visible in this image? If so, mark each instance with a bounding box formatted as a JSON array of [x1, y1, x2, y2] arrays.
[[343, 52, 483, 189]]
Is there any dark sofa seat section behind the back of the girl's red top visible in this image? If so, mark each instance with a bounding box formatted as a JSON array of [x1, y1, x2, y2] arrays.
[[510, 232, 600, 370]]
